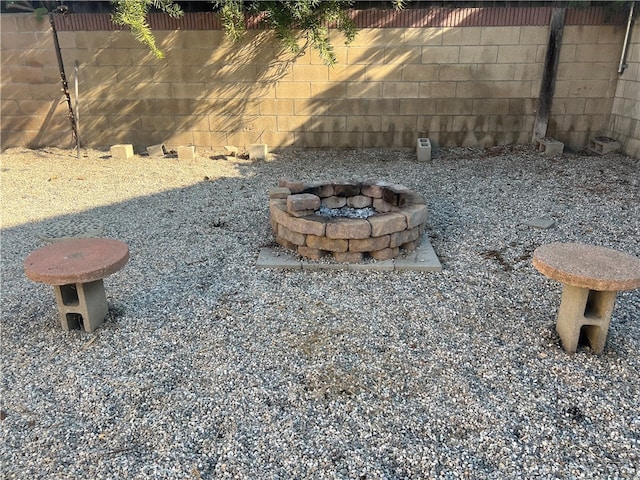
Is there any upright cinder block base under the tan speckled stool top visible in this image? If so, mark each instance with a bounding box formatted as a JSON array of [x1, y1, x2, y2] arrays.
[[556, 284, 617, 353]]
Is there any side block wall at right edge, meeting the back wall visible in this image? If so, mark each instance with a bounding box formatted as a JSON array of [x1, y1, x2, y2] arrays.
[[609, 21, 640, 158]]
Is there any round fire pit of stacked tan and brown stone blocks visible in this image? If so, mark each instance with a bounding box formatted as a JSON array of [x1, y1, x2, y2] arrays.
[[269, 180, 427, 263]]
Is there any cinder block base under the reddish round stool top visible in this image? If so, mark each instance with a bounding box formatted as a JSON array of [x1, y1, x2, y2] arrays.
[[54, 280, 109, 332]]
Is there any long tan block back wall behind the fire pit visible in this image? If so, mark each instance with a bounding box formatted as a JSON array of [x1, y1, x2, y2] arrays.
[[1, 8, 638, 154]]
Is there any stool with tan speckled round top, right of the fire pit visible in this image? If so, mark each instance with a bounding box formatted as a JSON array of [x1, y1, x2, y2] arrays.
[[533, 243, 640, 353]]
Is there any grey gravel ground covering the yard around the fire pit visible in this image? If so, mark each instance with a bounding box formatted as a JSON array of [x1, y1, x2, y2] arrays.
[[0, 147, 640, 479]]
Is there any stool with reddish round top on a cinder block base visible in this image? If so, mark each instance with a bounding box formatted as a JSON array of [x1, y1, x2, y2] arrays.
[[24, 238, 129, 332]]
